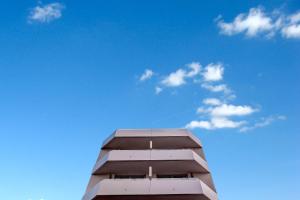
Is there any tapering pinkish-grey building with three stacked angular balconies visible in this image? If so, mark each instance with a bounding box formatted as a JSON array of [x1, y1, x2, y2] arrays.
[[82, 129, 218, 200]]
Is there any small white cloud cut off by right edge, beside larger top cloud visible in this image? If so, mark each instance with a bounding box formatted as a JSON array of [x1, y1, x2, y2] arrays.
[[281, 11, 300, 38]]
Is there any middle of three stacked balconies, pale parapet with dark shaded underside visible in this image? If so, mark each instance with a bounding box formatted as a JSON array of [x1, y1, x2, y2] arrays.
[[93, 149, 209, 175]]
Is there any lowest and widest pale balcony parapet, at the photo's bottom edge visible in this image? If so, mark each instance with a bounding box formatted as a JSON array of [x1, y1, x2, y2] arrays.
[[82, 178, 218, 200]]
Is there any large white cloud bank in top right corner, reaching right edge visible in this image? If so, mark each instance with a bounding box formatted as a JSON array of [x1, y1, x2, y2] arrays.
[[216, 6, 300, 38]]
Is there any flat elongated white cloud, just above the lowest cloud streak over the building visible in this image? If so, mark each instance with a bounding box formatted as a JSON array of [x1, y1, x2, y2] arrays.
[[210, 104, 257, 116]]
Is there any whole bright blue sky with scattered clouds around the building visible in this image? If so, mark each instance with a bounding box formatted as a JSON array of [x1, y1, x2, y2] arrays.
[[0, 0, 300, 200]]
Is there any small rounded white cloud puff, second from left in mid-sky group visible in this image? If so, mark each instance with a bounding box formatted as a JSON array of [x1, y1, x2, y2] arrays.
[[161, 69, 186, 87]]
